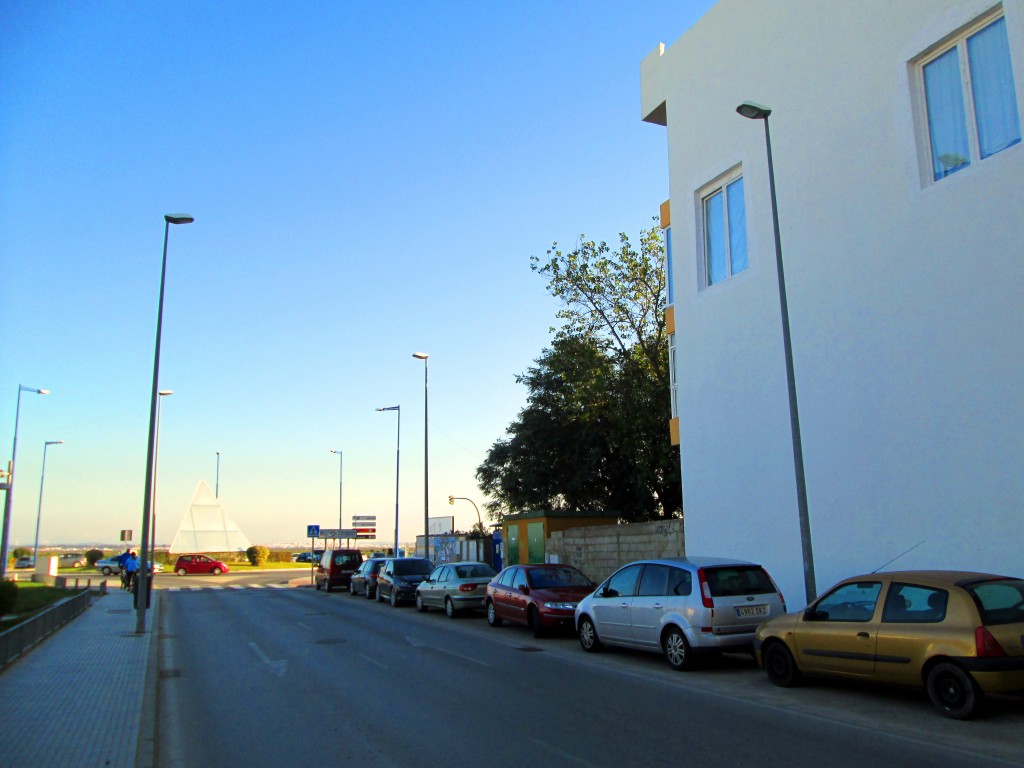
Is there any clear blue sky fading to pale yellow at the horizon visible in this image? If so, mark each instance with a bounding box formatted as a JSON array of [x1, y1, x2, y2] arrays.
[[0, 0, 712, 546]]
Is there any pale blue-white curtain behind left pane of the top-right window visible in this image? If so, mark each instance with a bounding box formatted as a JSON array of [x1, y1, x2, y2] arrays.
[[925, 48, 971, 180]]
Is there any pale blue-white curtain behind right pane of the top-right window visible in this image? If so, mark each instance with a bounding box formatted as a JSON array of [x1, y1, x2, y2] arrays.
[[967, 18, 1021, 158]]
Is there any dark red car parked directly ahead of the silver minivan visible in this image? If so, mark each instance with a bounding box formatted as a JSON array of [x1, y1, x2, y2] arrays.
[[484, 563, 595, 637]]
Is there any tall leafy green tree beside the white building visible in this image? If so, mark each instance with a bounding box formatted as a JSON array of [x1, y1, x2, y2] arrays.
[[476, 226, 682, 521]]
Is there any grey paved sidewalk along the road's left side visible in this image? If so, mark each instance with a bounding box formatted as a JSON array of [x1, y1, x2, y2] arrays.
[[0, 589, 160, 768]]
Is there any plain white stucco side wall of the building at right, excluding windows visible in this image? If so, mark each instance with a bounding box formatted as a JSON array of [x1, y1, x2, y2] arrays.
[[641, 0, 1024, 607]]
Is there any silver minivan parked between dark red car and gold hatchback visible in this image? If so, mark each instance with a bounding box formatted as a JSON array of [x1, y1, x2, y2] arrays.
[[575, 557, 785, 670]]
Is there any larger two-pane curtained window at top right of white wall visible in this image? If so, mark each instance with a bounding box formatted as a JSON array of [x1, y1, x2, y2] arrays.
[[919, 10, 1021, 181]]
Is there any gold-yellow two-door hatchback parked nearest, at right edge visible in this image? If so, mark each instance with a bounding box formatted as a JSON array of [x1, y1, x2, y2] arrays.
[[754, 570, 1024, 720]]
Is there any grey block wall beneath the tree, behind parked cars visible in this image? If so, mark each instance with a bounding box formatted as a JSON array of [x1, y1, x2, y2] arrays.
[[546, 518, 686, 582]]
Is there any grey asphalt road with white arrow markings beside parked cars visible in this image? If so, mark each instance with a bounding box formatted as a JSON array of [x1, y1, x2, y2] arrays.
[[158, 589, 1024, 768]]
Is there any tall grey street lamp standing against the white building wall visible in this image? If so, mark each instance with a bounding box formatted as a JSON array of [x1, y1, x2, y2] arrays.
[[736, 101, 817, 604]]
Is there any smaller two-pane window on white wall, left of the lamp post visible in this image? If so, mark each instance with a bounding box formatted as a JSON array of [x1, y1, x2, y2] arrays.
[[701, 175, 746, 286]]
